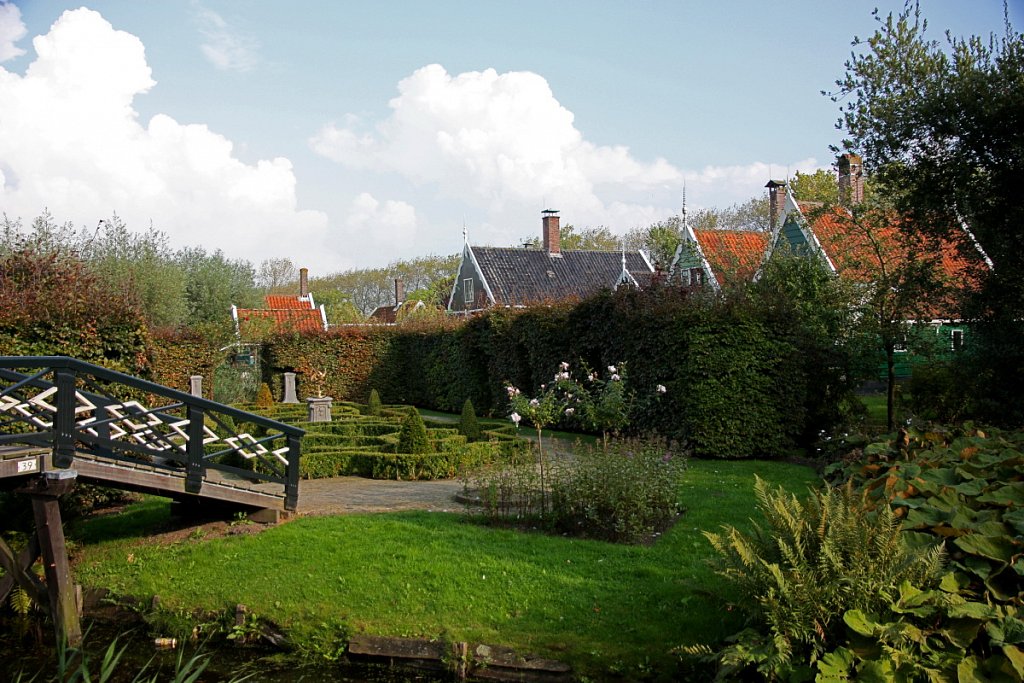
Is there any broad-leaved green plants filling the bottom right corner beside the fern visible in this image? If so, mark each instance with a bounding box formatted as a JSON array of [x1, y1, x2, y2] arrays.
[[819, 426, 1024, 680]]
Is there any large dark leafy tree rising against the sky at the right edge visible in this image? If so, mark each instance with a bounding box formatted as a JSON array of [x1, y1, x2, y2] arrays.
[[830, 2, 1024, 420]]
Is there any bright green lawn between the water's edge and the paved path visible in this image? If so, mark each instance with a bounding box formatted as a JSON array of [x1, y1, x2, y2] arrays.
[[70, 461, 817, 678]]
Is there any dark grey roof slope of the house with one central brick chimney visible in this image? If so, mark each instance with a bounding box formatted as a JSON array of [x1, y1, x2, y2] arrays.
[[472, 247, 653, 306]]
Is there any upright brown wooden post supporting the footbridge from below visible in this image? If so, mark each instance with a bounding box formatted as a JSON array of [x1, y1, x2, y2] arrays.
[[20, 470, 82, 647]]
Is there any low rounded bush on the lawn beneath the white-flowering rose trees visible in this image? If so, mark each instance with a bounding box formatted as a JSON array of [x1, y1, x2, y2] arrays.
[[551, 439, 686, 543]]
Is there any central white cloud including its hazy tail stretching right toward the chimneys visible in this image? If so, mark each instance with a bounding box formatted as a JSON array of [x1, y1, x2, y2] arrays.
[[309, 65, 816, 245]]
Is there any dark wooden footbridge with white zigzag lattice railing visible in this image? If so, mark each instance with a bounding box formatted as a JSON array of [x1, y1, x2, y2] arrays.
[[0, 356, 304, 644]]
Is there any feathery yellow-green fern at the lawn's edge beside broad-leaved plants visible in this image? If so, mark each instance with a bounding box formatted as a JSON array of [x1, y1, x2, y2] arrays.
[[684, 478, 943, 680]]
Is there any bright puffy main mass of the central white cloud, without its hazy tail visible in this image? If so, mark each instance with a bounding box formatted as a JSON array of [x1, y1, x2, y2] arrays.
[[310, 65, 682, 211]]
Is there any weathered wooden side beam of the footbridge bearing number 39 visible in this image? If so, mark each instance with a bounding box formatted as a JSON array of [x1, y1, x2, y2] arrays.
[[0, 446, 285, 510]]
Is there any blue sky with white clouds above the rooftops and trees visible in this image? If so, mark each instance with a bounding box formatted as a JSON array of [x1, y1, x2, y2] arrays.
[[0, 0, 1011, 275]]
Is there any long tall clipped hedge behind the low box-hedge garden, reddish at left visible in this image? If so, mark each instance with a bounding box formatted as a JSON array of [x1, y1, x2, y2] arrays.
[[265, 286, 857, 458]]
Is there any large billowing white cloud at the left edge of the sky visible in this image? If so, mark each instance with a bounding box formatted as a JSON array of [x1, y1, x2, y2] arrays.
[[0, 8, 331, 265]]
